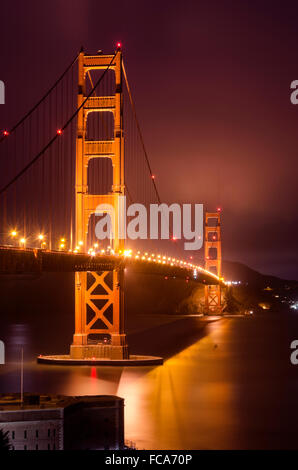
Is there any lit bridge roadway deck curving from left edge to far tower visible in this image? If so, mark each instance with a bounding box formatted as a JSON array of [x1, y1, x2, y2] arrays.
[[0, 245, 222, 285]]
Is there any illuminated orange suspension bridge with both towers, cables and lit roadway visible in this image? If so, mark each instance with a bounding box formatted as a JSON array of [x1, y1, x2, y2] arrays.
[[0, 43, 224, 365]]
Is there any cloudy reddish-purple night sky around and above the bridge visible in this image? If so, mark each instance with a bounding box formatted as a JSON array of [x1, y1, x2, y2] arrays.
[[0, 0, 298, 279]]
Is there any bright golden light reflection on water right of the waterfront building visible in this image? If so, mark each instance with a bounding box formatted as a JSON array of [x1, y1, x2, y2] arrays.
[[118, 339, 233, 449]]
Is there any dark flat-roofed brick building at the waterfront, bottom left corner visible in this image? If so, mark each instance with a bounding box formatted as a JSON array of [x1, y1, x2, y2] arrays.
[[0, 394, 124, 450]]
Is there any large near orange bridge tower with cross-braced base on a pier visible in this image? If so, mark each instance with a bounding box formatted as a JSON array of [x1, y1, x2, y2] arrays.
[[70, 50, 129, 359]]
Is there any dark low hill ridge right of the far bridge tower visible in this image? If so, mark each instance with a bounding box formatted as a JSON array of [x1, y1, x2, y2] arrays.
[[222, 261, 298, 288]]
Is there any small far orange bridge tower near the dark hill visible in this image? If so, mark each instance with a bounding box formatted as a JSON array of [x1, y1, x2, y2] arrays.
[[205, 211, 222, 314]]
